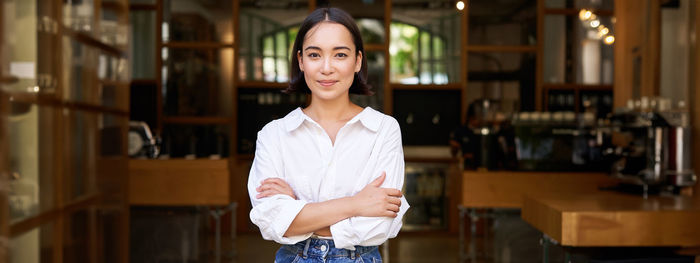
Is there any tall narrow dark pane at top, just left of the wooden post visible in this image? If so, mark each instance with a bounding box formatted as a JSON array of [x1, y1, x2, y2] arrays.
[[129, 10, 156, 79]]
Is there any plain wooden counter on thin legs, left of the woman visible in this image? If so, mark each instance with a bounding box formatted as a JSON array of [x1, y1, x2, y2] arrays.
[[129, 159, 234, 206]]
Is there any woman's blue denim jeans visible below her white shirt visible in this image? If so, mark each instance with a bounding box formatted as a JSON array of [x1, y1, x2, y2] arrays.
[[275, 238, 382, 263]]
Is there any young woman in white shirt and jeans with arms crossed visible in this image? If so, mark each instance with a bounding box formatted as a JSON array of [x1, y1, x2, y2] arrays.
[[248, 8, 409, 263]]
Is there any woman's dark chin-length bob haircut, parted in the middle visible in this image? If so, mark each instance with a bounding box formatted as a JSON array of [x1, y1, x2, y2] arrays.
[[283, 7, 373, 95]]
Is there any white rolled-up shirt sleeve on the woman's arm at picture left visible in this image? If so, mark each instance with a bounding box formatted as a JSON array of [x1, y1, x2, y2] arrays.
[[248, 122, 311, 244]]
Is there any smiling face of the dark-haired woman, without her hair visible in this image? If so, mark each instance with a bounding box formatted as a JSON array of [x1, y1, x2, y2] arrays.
[[297, 22, 362, 103]]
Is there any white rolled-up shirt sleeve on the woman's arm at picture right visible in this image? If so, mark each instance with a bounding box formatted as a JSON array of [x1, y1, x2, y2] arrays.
[[330, 118, 410, 250]]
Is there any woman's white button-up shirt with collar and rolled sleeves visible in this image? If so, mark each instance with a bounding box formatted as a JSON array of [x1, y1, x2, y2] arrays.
[[248, 107, 409, 250]]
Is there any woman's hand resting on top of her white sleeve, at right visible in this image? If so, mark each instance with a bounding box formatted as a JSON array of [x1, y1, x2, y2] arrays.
[[352, 172, 402, 217]]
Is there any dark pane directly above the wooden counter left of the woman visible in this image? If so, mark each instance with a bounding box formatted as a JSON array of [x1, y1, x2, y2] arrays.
[[161, 124, 231, 159]]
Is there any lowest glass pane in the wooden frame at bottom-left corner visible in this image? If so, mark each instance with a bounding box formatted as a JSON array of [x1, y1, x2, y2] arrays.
[[9, 223, 56, 263]]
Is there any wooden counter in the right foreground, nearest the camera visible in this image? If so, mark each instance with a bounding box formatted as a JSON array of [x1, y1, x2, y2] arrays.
[[522, 192, 700, 247]]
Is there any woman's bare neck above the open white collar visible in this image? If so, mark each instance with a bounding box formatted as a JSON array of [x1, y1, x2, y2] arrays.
[[304, 96, 359, 121]]
